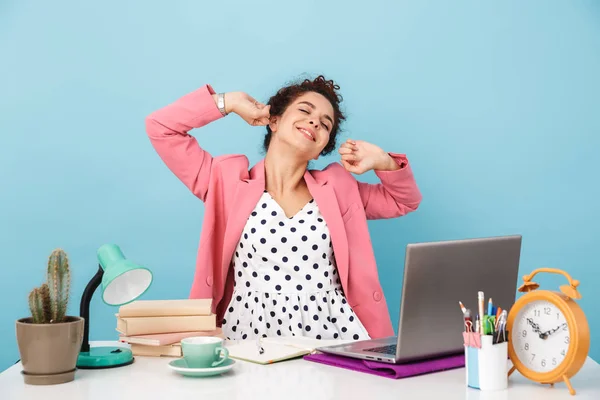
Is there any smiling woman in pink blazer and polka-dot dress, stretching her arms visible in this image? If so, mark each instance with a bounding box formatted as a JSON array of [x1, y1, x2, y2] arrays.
[[146, 76, 421, 340]]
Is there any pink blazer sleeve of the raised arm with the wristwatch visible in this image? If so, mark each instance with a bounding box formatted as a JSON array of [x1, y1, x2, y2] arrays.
[[146, 85, 223, 201]]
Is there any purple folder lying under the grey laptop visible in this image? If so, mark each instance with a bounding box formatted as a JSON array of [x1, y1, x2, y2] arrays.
[[304, 353, 465, 379]]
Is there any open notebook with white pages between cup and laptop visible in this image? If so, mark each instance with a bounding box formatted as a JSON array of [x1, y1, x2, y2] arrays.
[[226, 336, 353, 364]]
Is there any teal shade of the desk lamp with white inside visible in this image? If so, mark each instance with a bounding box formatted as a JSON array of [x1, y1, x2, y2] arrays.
[[98, 244, 152, 306]]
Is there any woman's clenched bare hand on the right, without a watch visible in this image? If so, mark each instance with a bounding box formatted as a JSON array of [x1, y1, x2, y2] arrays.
[[338, 139, 400, 175]]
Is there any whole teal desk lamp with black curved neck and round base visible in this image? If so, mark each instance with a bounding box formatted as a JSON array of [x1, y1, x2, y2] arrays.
[[77, 244, 152, 369]]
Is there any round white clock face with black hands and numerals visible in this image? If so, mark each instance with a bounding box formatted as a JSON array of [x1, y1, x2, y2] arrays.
[[510, 300, 571, 373]]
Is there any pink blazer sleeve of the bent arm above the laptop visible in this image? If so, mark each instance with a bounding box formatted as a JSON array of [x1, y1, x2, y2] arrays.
[[358, 153, 422, 219]]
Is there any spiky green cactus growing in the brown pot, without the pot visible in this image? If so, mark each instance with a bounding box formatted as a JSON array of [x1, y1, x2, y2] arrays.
[[29, 249, 71, 324]]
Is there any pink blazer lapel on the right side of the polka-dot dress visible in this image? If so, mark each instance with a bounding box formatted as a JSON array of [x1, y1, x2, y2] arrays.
[[304, 170, 349, 291]]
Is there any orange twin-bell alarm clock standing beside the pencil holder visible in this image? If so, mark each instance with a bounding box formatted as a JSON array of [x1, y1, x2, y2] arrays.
[[507, 268, 590, 395]]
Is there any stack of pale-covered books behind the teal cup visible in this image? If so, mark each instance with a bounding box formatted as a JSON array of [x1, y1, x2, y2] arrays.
[[116, 299, 223, 357]]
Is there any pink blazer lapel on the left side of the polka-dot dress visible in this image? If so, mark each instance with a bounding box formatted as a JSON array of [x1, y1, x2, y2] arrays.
[[221, 161, 265, 282]]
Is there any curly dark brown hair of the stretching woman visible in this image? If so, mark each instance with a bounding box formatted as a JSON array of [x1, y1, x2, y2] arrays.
[[263, 75, 346, 156]]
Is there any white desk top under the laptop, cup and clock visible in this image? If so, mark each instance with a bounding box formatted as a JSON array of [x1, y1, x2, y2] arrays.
[[0, 342, 600, 400]]
